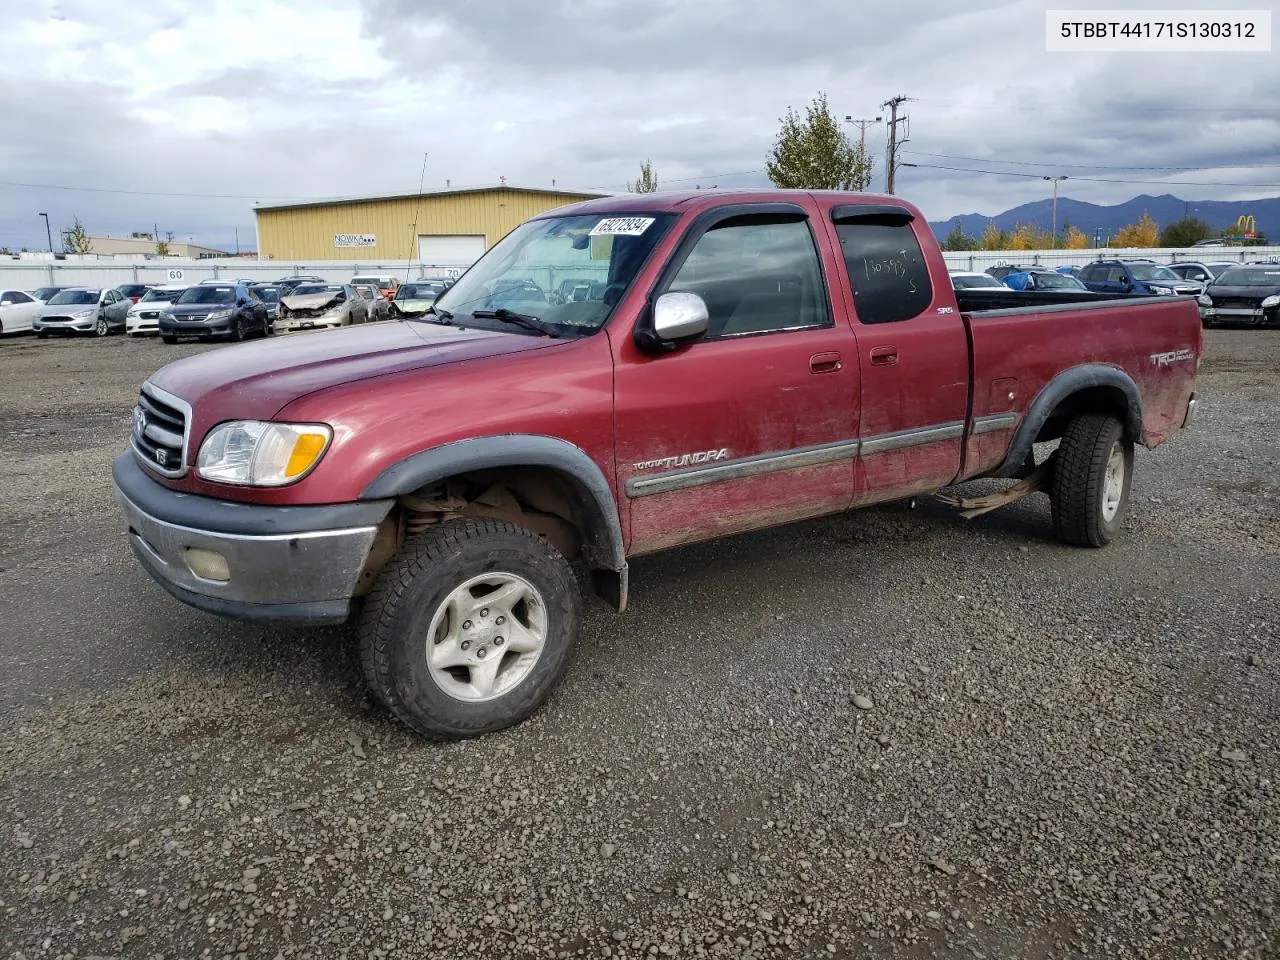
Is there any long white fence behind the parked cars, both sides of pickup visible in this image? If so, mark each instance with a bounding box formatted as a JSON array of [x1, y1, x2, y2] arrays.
[[0, 247, 1280, 291]]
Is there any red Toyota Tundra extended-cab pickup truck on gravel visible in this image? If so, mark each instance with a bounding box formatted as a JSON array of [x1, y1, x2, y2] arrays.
[[113, 191, 1202, 737]]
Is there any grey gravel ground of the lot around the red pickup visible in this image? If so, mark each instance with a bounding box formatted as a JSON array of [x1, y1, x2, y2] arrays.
[[0, 330, 1280, 960]]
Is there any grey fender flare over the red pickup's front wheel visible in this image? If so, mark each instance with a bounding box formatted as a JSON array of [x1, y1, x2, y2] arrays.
[[360, 434, 627, 572]]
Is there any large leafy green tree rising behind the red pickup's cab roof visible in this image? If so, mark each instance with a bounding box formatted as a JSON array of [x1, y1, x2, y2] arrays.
[[765, 93, 872, 189]]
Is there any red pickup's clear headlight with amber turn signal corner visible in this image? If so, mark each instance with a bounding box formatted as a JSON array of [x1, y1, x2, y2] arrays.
[[196, 420, 333, 486]]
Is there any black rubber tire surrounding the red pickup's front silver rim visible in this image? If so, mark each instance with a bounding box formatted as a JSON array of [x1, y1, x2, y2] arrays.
[[360, 520, 582, 740]]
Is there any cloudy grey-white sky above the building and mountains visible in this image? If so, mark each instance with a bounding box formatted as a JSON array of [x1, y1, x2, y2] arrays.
[[0, 0, 1280, 248]]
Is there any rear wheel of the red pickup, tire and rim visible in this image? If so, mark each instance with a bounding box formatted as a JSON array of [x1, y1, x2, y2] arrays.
[[1050, 413, 1133, 547]]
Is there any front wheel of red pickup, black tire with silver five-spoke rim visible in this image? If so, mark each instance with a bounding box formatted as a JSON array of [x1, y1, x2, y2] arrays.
[[360, 520, 581, 740]]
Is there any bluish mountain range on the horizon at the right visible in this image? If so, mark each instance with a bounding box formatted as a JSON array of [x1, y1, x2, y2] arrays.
[[929, 193, 1280, 243]]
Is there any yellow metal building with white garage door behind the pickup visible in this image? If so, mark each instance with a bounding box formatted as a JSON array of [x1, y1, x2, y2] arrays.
[[253, 184, 605, 266]]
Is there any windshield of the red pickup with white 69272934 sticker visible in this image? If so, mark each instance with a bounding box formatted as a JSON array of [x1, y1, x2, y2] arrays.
[[428, 214, 676, 335]]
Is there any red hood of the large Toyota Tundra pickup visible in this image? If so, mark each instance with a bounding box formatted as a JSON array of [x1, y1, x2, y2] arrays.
[[150, 323, 562, 426]]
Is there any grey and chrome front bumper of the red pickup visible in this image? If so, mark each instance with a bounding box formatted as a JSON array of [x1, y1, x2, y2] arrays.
[[111, 452, 392, 623]]
